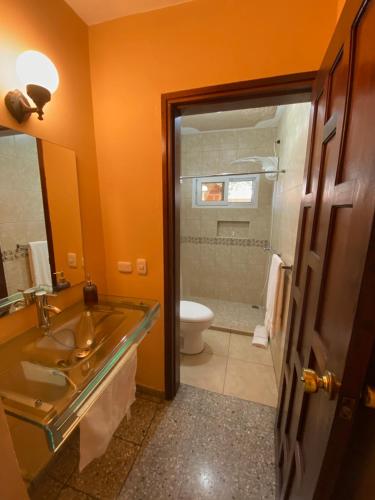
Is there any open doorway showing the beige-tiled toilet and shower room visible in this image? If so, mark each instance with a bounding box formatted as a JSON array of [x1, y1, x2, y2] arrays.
[[179, 102, 311, 407]]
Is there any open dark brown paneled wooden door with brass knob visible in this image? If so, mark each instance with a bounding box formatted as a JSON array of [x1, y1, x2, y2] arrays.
[[276, 0, 375, 500]]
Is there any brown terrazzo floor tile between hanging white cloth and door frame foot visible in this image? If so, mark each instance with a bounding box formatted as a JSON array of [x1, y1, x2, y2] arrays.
[[116, 398, 158, 445]]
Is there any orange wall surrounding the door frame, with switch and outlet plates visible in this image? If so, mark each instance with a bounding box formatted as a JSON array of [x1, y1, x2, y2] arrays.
[[90, 0, 337, 389]]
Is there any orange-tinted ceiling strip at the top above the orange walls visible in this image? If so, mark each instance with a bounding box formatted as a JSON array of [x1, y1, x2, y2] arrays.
[[65, 0, 192, 25]]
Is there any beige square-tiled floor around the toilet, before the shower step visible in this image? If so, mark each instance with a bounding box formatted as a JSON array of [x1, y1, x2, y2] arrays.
[[181, 330, 277, 407]]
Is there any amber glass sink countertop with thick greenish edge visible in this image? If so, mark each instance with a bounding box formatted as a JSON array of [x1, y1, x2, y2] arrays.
[[0, 296, 160, 451]]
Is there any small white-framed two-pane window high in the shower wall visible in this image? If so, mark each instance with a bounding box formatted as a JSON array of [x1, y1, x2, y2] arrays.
[[193, 175, 259, 208]]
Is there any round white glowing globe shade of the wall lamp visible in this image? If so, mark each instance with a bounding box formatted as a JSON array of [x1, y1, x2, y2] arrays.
[[16, 50, 59, 94]]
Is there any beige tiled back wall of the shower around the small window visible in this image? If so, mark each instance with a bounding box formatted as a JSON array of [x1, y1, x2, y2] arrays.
[[181, 124, 276, 304]]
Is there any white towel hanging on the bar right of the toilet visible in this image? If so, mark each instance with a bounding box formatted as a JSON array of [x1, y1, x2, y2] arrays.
[[264, 254, 284, 338]]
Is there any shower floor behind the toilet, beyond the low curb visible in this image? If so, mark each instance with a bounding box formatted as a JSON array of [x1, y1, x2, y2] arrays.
[[184, 297, 264, 333]]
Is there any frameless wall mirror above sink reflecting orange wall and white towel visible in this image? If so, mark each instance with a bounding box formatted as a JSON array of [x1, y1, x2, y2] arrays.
[[0, 127, 85, 312]]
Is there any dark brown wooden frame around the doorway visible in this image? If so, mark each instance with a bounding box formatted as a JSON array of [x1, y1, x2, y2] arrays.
[[161, 71, 316, 399]]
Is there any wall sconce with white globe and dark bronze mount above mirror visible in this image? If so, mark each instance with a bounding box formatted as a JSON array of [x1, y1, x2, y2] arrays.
[[5, 50, 59, 123]]
